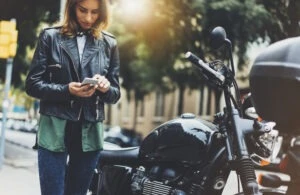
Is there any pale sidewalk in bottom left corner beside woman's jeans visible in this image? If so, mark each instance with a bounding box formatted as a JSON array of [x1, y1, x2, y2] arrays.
[[0, 161, 40, 195]]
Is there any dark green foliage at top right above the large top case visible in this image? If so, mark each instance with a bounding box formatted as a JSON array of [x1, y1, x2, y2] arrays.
[[203, 0, 300, 68]]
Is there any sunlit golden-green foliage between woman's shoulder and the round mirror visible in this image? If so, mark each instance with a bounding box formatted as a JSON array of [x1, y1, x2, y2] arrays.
[[112, 0, 205, 99]]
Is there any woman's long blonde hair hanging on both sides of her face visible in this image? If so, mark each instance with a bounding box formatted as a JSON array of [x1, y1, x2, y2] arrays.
[[61, 0, 110, 39]]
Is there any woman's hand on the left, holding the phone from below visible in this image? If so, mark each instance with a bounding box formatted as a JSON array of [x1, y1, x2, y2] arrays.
[[69, 82, 97, 97]]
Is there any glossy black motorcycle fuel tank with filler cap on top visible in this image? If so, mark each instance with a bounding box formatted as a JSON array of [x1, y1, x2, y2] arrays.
[[139, 113, 217, 164]]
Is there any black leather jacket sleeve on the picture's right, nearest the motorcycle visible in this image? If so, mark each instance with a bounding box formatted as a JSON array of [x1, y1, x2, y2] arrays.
[[97, 39, 121, 104]]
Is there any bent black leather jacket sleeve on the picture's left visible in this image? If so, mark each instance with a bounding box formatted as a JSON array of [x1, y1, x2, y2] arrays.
[[25, 30, 71, 102]]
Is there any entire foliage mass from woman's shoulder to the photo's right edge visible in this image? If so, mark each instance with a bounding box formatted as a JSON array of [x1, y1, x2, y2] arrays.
[[109, 0, 300, 114]]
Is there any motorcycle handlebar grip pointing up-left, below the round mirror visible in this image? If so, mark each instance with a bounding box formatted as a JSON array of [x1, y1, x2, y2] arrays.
[[185, 51, 225, 84]]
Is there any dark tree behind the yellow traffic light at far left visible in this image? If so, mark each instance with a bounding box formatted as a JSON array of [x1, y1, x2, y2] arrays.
[[0, 0, 60, 88]]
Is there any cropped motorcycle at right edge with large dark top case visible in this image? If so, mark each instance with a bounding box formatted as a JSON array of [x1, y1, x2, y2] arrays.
[[249, 34, 300, 195]]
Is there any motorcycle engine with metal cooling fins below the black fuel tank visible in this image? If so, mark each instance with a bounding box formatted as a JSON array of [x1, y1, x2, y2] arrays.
[[131, 166, 187, 195]]
